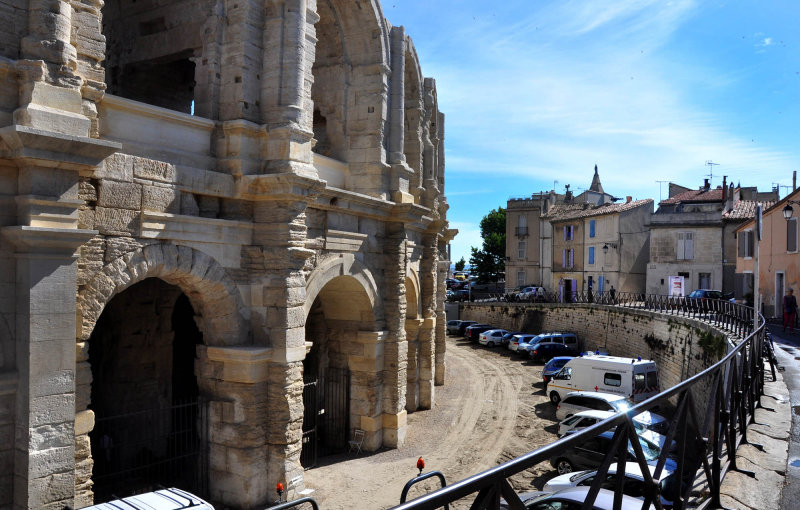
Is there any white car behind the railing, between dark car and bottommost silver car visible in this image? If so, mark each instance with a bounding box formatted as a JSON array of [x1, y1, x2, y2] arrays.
[[542, 462, 677, 507]]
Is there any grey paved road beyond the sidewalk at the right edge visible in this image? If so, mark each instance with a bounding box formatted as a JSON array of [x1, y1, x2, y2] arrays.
[[769, 325, 800, 510]]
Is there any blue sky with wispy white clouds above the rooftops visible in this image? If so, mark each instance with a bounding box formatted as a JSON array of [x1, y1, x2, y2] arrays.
[[382, 0, 800, 261]]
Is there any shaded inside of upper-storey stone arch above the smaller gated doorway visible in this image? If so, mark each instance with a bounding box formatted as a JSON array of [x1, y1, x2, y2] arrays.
[[311, 0, 390, 196]]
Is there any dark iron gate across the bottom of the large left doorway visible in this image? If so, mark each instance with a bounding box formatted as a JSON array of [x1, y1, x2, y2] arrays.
[[91, 399, 208, 503]]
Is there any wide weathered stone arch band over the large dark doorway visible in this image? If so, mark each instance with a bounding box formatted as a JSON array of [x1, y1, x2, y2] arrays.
[[78, 243, 249, 346]]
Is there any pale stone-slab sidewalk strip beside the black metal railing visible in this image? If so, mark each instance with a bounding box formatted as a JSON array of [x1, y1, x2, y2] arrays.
[[721, 324, 800, 510]]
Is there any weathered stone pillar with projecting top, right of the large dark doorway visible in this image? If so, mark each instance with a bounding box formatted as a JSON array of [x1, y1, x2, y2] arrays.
[[195, 345, 274, 508]]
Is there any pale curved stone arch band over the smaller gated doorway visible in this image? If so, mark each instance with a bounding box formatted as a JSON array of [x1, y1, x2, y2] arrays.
[[304, 254, 384, 323]]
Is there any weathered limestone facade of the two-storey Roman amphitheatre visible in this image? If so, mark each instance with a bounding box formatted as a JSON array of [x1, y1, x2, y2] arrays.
[[0, 0, 454, 509]]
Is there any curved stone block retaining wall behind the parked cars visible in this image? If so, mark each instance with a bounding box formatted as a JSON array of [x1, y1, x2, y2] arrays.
[[459, 303, 722, 406]]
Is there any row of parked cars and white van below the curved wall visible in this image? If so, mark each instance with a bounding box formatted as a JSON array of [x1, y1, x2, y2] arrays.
[[447, 321, 681, 509]]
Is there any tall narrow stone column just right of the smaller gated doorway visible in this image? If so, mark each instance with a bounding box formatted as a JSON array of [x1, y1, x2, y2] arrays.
[[383, 223, 408, 447]]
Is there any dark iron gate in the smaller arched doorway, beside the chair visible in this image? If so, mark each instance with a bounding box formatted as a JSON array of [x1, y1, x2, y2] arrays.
[[300, 367, 350, 469]]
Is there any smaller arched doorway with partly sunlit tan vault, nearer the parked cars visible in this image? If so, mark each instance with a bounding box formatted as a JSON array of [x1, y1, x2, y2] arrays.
[[301, 276, 380, 468]]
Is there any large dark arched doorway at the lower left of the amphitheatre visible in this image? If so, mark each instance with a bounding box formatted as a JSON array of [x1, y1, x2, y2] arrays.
[[89, 278, 206, 502]]
